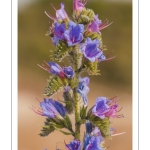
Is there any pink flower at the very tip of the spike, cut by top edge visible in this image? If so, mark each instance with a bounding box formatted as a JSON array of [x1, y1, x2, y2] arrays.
[[73, 0, 87, 12]]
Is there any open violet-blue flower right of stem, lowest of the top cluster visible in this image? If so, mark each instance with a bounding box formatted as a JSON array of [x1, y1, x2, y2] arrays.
[[80, 38, 102, 62]]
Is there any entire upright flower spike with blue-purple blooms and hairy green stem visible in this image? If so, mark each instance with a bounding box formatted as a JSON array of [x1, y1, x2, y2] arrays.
[[32, 0, 123, 150]]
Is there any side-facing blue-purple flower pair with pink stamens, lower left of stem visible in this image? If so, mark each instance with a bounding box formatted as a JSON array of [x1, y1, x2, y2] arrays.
[[32, 98, 66, 118]]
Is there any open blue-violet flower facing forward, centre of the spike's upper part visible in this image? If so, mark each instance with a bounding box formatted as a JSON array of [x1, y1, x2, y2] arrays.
[[64, 21, 84, 46]]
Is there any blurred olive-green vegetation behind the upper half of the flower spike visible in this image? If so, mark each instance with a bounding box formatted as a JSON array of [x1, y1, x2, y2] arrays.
[[18, 0, 132, 90]]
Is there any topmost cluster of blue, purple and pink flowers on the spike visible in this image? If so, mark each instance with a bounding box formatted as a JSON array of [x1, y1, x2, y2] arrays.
[[46, 0, 110, 62]]
